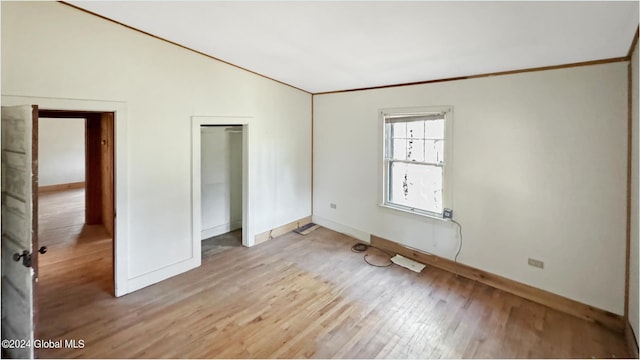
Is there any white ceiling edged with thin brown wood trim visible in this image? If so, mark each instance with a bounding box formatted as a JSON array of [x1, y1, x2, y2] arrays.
[[69, 1, 639, 93]]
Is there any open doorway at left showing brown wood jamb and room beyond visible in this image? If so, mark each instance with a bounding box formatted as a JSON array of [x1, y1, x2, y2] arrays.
[[34, 109, 115, 355]]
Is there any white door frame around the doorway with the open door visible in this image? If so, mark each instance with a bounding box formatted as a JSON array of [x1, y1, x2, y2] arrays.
[[2, 95, 129, 297]]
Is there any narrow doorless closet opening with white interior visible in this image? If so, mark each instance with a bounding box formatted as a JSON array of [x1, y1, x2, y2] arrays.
[[200, 125, 243, 257]]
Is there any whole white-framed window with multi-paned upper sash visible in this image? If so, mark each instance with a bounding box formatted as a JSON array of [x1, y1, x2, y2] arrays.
[[381, 107, 452, 217]]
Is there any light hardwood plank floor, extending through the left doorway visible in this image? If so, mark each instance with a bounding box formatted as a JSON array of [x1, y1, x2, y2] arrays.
[[36, 188, 629, 358]]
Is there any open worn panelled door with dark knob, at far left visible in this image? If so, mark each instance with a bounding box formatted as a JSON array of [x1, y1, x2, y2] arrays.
[[1, 106, 38, 358]]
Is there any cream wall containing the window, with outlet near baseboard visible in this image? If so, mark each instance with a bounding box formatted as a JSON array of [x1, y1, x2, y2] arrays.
[[313, 62, 627, 315]]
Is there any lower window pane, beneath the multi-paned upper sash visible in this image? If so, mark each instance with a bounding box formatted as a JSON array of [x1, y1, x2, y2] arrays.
[[389, 162, 442, 213]]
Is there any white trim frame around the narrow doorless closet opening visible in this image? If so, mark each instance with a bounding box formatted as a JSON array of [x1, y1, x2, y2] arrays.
[[191, 116, 255, 258]]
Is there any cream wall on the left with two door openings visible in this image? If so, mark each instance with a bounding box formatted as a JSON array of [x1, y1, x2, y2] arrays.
[[2, 1, 311, 292]]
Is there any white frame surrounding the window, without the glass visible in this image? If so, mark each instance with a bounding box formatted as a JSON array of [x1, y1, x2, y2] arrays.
[[379, 106, 453, 219]]
